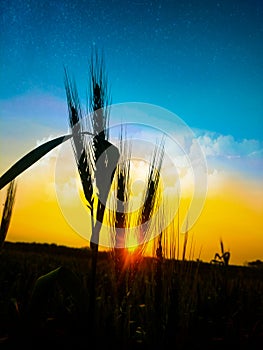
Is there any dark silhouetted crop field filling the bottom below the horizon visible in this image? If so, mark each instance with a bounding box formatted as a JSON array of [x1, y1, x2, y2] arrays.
[[0, 242, 263, 350]]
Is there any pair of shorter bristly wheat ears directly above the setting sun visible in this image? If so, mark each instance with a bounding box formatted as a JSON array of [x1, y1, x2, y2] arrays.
[[108, 129, 164, 302]]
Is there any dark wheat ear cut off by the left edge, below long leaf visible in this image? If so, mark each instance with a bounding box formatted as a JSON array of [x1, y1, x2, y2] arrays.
[[0, 180, 17, 249]]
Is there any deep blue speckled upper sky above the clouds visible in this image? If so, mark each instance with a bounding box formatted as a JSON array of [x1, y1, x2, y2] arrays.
[[0, 0, 263, 141]]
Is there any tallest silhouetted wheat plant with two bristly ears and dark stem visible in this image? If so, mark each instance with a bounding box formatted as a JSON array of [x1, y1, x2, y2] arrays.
[[65, 51, 119, 328]]
